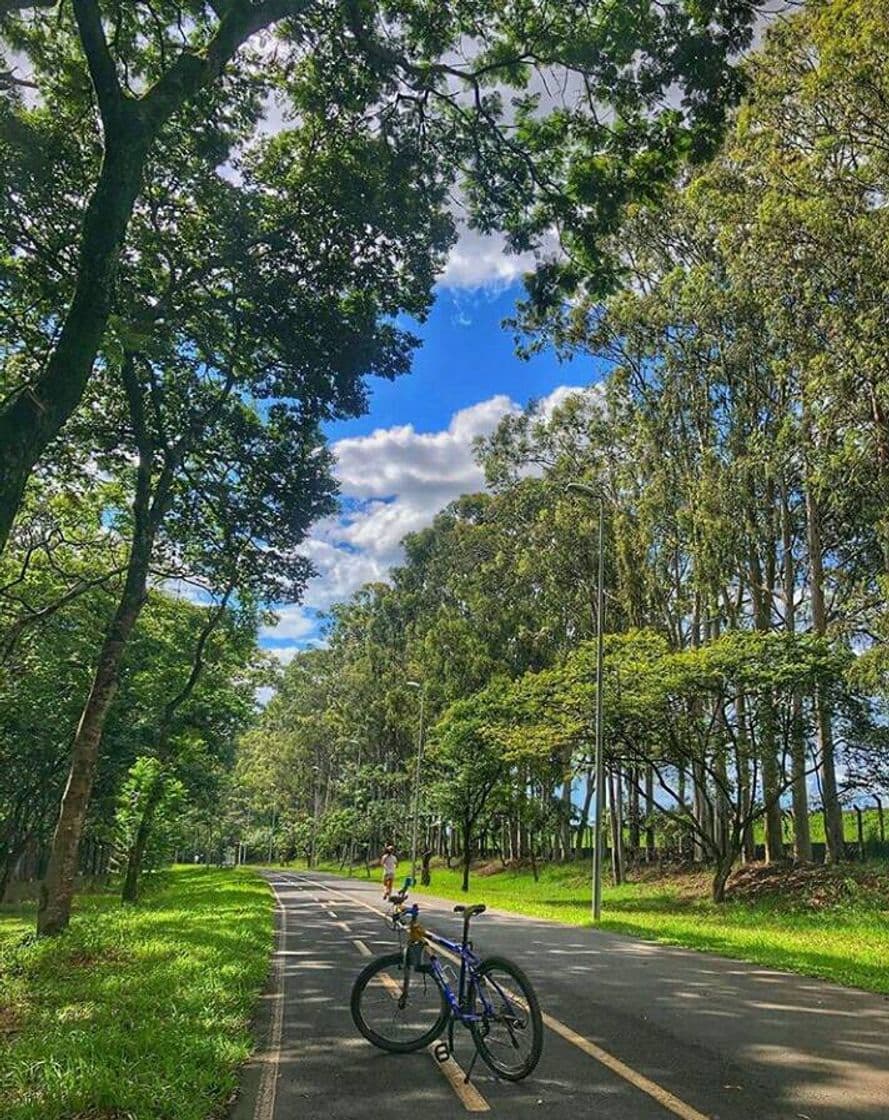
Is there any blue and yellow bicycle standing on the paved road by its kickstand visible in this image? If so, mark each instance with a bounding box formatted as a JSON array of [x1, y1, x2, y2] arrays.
[[350, 878, 543, 1082]]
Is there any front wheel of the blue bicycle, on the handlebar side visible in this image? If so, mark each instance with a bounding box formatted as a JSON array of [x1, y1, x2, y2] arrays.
[[352, 953, 449, 1054]]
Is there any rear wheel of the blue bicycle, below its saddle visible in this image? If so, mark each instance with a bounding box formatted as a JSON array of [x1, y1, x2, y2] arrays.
[[469, 956, 543, 1081]]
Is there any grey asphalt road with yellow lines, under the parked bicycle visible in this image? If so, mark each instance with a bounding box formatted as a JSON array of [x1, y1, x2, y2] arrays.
[[231, 871, 889, 1120]]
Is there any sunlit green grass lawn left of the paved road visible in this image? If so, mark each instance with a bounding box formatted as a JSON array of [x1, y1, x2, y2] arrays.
[[0, 867, 273, 1120]]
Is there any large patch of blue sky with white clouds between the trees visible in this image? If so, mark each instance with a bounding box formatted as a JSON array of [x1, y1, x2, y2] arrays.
[[260, 233, 601, 663]]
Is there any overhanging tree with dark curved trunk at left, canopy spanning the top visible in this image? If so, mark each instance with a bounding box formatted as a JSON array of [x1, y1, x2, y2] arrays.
[[0, 0, 770, 547]]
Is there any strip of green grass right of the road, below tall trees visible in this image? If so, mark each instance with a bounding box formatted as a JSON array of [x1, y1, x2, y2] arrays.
[[309, 860, 889, 992]]
